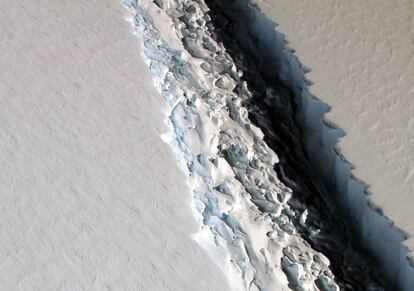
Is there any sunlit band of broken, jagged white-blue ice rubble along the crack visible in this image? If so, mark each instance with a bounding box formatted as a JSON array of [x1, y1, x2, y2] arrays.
[[124, 0, 380, 290]]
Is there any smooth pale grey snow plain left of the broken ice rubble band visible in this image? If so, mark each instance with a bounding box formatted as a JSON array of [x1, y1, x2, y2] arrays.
[[0, 0, 227, 291]]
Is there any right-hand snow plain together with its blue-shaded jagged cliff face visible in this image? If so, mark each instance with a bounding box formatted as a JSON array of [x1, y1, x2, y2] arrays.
[[252, 0, 414, 290]]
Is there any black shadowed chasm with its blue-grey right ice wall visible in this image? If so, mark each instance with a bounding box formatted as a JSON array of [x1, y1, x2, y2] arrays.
[[205, 0, 414, 290]]
